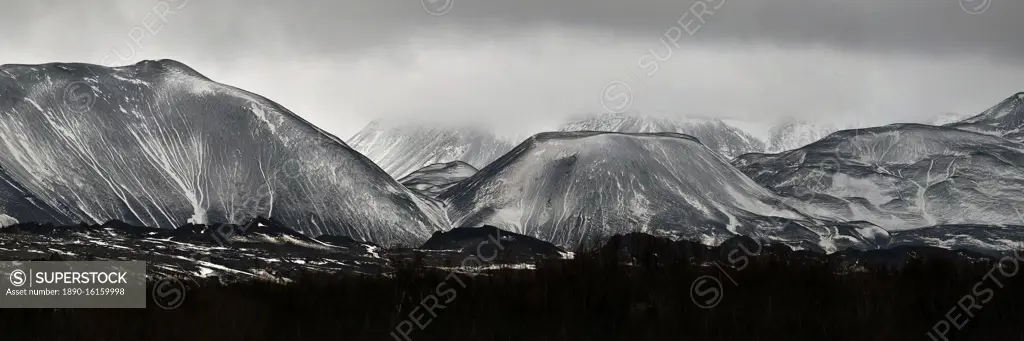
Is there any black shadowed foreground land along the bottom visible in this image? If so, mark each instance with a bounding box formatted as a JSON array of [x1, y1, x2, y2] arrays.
[[0, 236, 1024, 341]]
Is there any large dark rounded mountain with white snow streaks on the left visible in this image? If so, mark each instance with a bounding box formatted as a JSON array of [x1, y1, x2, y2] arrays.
[[0, 59, 447, 244]]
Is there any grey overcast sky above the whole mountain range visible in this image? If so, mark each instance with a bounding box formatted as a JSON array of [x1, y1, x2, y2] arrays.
[[0, 0, 1024, 138]]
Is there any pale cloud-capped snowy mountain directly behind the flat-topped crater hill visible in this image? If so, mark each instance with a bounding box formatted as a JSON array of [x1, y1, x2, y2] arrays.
[[558, 113, 765, 158]]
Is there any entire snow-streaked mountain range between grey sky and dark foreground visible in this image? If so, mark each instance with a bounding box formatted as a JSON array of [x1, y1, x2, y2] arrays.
[[0, 59, 1024, 252]]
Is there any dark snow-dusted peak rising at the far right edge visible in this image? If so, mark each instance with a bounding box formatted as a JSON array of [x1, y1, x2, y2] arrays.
[[946, 92, 1024, 142]]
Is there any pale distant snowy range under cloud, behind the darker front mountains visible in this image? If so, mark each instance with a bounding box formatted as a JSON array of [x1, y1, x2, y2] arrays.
[[348, 113, 839, 178]]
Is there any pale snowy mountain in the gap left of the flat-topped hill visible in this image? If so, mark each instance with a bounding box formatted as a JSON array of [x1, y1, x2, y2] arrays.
[[348, 121, 519, 178]]
